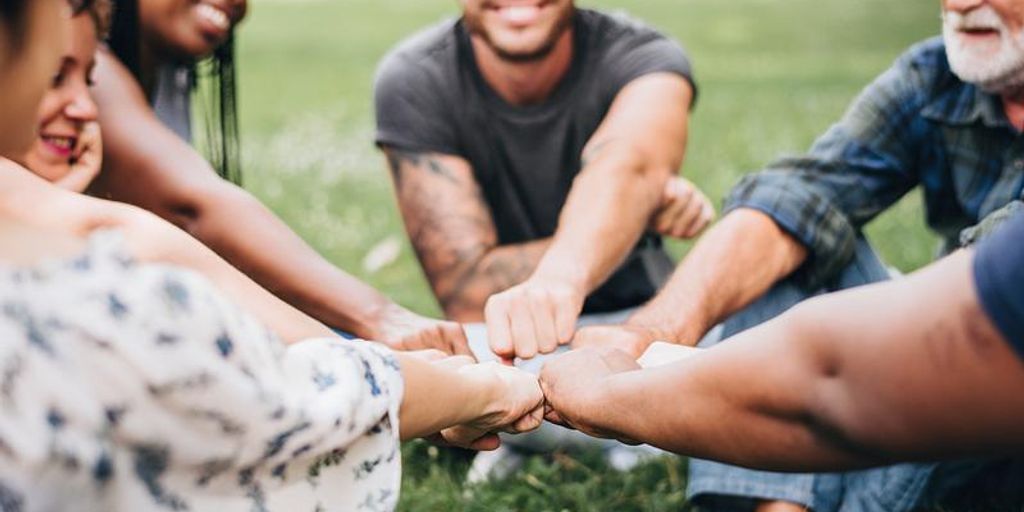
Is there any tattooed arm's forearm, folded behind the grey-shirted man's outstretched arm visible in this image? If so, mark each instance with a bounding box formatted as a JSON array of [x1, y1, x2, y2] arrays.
[[440, 239, 551, 323]]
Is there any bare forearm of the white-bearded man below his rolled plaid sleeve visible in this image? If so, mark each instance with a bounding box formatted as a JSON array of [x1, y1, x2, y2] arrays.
[[628, 209, 807, 345]]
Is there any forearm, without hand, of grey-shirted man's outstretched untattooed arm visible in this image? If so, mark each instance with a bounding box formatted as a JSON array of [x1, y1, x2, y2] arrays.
[[535, 146, 674, 294]]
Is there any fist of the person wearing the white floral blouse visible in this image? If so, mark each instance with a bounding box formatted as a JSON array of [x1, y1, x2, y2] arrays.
[[438, 358, 544, 450]]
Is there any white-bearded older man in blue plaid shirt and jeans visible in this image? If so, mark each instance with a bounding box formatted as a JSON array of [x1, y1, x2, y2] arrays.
[[557, 0, 1024, 512]]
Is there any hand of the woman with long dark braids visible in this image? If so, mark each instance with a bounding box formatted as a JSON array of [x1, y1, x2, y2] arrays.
[[373, 304, 473, 357]]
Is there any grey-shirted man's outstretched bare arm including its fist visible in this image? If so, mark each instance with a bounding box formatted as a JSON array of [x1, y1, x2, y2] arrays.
[[485, 74, 692, 358]]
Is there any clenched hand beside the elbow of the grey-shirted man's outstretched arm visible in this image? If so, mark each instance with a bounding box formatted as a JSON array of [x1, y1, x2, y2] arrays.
[[650, 176, 715, 239]]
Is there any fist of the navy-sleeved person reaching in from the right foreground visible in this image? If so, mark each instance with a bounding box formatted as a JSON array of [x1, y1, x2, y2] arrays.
[[541, 348, 640, 443]]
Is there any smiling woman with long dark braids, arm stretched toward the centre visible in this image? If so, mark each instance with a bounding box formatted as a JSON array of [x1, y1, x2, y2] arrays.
[[91, 0, 469, 354]]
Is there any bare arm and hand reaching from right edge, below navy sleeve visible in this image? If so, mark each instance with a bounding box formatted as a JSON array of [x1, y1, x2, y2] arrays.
[[542, 249, 1024, 471]]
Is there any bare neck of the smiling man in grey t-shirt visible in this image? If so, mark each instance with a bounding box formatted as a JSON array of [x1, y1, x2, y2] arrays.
[[471, 29, 573, 106]]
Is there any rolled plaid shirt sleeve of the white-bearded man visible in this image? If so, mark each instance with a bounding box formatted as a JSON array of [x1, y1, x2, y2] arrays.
[[725, 45, 934, 289]]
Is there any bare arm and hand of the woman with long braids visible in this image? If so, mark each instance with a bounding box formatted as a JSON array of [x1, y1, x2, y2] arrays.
[[94, 52, 465, 351]]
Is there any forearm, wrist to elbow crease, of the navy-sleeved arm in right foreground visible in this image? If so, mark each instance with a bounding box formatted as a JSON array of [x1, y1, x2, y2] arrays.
[[590, 324, 870, 471]]
